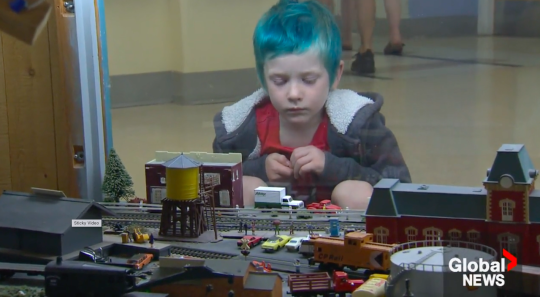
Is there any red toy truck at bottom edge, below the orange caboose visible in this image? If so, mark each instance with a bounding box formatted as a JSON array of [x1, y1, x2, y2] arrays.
[[289, 271, 364, 297]]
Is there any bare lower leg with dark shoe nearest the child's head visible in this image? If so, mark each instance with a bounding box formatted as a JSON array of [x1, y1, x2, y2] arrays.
[[351, 0, 376, 74]]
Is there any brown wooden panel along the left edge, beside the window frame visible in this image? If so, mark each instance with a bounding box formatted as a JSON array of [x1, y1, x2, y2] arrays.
[[0, 0, 82, 197]]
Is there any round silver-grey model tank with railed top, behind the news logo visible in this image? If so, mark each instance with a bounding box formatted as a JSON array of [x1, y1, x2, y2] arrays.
[[386, 240, 497, 297]]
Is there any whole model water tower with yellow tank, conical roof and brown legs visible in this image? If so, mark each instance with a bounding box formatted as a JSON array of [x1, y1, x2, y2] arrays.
[[159, 154, 207, 237]]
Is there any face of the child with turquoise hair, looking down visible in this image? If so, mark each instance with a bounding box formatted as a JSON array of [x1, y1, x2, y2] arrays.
[[264, 51, 343, 125]]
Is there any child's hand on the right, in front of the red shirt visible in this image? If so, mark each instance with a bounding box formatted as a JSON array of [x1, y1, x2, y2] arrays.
[[291, 145, 325, 178]]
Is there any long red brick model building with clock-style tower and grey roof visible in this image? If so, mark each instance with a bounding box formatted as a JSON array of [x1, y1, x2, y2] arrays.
[[366, 144, 540, 266]]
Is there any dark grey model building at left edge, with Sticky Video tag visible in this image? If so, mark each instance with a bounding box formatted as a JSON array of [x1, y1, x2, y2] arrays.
[[0, 191, 116, 256]]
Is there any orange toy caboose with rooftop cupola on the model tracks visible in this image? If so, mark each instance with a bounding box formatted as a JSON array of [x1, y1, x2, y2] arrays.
[[308, 231, 396, 274]]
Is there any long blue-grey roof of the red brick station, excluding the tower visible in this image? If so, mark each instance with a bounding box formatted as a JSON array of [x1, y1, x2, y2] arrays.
[[366, 179, 487, 219]]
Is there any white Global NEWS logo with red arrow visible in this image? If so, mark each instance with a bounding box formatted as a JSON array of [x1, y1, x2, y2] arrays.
[[448, 249, 517, 290]]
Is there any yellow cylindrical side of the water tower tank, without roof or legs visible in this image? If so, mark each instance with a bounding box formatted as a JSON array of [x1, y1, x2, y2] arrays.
[[166, 167, 199, 200]]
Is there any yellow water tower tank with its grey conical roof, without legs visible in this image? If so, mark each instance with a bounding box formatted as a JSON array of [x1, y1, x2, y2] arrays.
[[163, 154, 202, 200]]
